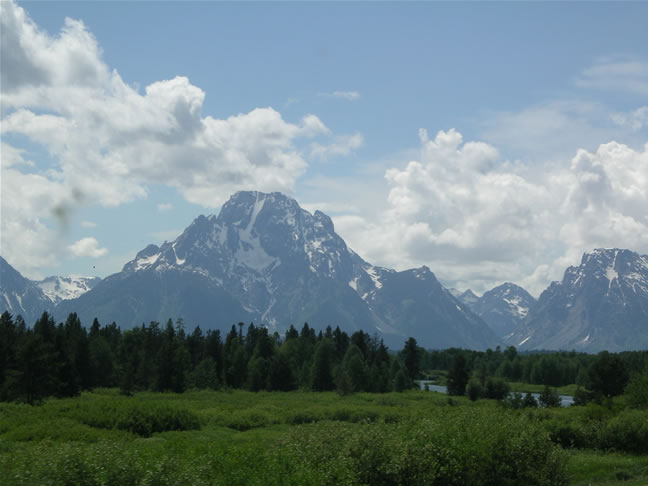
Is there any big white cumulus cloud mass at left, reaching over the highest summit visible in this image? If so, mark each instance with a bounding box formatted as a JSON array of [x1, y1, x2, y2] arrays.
[[0, 1, 350, 271]]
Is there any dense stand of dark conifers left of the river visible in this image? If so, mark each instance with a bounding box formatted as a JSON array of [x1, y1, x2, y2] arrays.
[[0, 312, 421, 403]]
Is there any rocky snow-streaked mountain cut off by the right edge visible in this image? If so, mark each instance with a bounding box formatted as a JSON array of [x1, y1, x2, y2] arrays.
[[506, 248, 648, 352]]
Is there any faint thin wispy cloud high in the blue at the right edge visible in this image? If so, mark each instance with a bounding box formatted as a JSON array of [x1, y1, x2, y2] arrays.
[[575, 56, 648, 95]]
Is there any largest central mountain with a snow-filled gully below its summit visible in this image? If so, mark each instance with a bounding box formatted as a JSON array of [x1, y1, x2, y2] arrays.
[[56, 192, 498, 348]]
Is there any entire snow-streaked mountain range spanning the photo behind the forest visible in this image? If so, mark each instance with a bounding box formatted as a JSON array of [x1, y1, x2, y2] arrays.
[[0, 192, 648, 351]]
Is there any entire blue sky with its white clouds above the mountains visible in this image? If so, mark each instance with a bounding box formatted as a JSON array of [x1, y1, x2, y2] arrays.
[[0, 2, 648, 294]]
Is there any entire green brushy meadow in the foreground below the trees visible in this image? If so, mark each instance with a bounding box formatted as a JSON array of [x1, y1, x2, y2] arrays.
[[0, 390, 648, 486]]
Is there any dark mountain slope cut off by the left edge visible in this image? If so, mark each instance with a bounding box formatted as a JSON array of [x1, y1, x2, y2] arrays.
[[0, 257, 53, 325]]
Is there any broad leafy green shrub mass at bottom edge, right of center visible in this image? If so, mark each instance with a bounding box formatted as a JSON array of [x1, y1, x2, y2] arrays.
[[278, 409, 566, 486]]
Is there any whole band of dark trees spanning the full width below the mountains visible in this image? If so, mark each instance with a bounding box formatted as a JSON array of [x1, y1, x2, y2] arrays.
[[0, 311, 648, 404]]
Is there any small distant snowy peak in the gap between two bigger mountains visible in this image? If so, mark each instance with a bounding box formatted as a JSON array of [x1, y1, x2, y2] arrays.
[[461, 283, 536, 337]]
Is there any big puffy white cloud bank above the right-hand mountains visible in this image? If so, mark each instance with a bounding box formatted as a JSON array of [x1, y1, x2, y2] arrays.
[[335, 130, 648, 294]]
